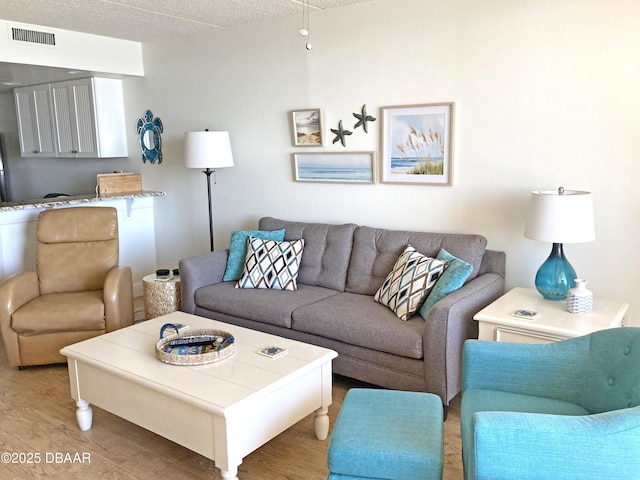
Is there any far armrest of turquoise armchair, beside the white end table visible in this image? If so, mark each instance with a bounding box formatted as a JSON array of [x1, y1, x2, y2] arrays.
[[462, 337, 590, 402]]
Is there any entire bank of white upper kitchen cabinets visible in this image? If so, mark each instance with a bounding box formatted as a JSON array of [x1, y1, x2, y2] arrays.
[[15, 77, 128, 158]]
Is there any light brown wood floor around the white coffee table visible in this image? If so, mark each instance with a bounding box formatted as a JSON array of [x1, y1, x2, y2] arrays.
[[0, 301, 462, 480]]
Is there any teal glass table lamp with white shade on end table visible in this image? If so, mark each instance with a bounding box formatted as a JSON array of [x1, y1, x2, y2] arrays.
[[524, 187, 596, 300]]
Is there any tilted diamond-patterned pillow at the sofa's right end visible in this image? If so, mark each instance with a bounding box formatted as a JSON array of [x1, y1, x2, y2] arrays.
[[373, 245, 447, 321]]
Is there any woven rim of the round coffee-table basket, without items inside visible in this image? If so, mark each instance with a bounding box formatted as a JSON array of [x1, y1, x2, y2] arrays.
[[156, 324, 236, 365]]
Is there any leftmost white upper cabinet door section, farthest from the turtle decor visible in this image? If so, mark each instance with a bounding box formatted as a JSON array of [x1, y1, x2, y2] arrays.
[[14, 84, 56, 157]]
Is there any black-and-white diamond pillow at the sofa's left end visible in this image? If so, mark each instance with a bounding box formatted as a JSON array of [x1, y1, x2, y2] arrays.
[[236, 237, 304, 290]]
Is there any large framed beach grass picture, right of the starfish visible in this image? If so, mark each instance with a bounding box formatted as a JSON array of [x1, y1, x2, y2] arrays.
[[380, 103, 454, 185]]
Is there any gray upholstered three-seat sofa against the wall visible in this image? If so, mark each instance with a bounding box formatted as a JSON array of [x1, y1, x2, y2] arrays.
[[179, 217, 505, 406]]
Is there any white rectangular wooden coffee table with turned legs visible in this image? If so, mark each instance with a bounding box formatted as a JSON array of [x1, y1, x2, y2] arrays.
[[61, 312, 337, 479]]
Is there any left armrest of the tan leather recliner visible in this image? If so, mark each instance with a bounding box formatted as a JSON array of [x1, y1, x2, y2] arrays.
[[0, 272, 40, 367]]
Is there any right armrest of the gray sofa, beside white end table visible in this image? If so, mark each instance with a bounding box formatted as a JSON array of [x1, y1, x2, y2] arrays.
[[423, 273, 504, 405]]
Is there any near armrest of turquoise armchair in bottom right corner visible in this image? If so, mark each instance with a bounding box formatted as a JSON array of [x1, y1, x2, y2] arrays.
[[469, 407, 640, 480]]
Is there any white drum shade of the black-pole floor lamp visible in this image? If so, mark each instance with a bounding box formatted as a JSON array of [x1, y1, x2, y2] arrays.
[[184, 131, 233, 169]]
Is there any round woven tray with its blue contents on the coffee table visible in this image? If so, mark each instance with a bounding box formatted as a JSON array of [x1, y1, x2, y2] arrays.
[[156, 323, 236, 365]]
